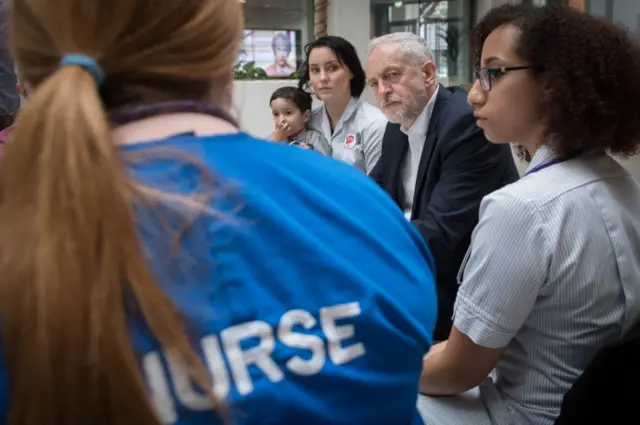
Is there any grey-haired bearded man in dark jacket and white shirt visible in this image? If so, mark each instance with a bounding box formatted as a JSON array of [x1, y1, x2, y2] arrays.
[[366, 33, 519, 341]]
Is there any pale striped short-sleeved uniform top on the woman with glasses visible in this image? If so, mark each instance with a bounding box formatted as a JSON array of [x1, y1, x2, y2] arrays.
[[454, 147, 640, 425]]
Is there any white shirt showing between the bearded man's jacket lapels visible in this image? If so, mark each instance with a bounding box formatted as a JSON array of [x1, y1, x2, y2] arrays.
[[401, 86, 440, 220]]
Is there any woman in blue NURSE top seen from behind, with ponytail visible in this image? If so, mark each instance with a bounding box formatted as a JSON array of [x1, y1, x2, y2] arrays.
[[0, 0, 435, 425]]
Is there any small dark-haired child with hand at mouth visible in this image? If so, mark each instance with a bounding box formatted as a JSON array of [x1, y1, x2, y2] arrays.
[[269, 87, 331, 156]]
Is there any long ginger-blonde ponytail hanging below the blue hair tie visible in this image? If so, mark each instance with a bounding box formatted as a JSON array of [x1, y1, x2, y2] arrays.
[[0, 67, 213, 425]]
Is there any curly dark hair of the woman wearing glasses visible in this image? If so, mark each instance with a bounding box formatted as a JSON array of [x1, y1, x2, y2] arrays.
[[473, 5, 640, 156]]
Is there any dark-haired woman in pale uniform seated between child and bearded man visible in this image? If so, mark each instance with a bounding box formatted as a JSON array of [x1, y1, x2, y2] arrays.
[[298, 36, 387, 173]]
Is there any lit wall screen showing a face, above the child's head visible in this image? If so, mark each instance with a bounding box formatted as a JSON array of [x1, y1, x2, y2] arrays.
[[239, 29, 301, 78]]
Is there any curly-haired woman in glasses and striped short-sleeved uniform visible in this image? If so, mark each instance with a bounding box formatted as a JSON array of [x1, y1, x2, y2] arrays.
[[419, 5, 640, 425]]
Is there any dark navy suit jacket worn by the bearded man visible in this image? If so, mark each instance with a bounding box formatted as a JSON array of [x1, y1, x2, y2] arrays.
[[370, 86, 519, 340]]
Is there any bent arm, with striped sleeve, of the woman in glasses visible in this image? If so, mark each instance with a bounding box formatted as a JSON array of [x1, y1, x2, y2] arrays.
[[420, 194, 551, 395]]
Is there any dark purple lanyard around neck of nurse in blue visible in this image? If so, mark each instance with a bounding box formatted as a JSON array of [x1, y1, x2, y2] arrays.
[[109, 100, 238, 126]]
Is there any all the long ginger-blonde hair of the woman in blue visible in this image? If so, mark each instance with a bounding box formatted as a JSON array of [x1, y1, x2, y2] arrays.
[[0, 0, 243, 425]]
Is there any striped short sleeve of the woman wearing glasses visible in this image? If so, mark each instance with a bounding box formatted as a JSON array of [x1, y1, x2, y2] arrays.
[[454, 191, 552, 348]]
